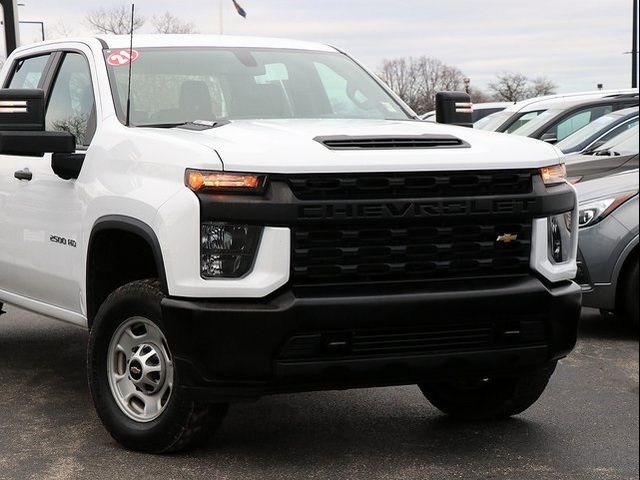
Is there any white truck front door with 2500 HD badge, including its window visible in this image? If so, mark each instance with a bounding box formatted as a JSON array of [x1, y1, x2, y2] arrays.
[[0, 47, 97, 313]]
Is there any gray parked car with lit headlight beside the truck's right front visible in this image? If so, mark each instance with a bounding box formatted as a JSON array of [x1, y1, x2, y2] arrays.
[[569, 169, 638, 326]]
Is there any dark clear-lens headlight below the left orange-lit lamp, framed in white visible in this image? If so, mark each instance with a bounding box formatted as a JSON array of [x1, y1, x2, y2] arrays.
[[200, 222, 262, 278]]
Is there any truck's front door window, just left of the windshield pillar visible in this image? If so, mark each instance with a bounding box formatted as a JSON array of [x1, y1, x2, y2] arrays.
[[45, 53, 96, 147]]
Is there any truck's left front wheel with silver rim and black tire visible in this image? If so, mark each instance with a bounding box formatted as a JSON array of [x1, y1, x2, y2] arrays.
[[88, 280, 228, 453]]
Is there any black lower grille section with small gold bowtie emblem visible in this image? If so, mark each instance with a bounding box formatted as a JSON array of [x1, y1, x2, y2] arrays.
[[292, 219, 531, 286]]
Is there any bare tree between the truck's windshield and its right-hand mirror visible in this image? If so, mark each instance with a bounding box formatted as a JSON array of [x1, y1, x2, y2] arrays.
[[379, 56, 464, 113]]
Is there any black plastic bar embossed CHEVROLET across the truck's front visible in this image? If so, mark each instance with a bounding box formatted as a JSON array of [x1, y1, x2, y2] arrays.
[[196, 175, 575, 227]]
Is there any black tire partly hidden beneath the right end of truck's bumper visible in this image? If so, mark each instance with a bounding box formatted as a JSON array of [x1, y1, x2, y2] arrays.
[[419, 362, 556, 420]]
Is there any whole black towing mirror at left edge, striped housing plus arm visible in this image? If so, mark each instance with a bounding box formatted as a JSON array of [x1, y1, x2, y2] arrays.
[[0, 89, 76, 157]]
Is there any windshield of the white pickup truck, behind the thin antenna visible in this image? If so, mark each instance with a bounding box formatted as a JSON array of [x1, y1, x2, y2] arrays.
[[105, 47, 411, 126]]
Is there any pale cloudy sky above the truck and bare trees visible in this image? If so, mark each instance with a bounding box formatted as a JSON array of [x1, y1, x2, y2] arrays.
[[6, 0, 632, 92]]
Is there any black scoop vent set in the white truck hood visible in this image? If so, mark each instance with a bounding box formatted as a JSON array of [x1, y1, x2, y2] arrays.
[[314, 135, 469, 150]]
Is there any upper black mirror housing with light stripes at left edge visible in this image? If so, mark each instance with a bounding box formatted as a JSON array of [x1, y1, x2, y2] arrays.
[[0, 88, 45, 132]]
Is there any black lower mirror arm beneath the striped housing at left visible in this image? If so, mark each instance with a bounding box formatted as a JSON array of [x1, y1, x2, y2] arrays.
[[0, 131, 76, 157]]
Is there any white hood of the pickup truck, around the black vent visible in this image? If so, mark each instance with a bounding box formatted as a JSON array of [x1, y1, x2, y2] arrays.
[[148, 120, 561, 173]]
